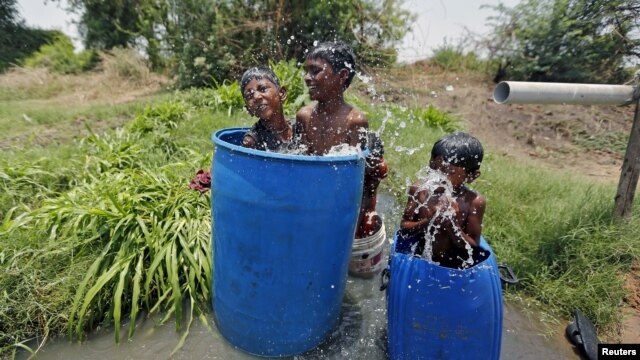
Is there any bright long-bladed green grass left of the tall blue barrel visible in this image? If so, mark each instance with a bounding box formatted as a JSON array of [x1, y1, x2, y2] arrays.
[[0, 97, 211, 354]]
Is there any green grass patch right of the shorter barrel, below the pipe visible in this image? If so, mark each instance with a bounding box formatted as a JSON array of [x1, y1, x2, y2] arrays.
[[474, 156, 640, 333]]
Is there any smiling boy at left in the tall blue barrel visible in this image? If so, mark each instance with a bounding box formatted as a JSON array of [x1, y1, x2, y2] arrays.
[[240, 66, 294, 151]]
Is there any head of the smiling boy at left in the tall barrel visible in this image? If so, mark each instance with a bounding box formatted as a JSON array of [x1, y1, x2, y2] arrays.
[[240, 66, 287, 119]]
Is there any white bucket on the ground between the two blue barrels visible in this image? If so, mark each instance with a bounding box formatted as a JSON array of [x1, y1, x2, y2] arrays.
[[349, 224, 387, 277]]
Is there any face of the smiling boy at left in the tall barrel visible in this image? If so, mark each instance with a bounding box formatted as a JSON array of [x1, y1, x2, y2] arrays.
[[242, 78, 287, 120]]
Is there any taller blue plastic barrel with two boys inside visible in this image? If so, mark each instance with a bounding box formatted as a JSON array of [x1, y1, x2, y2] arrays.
[[211, 128, 364, 356]]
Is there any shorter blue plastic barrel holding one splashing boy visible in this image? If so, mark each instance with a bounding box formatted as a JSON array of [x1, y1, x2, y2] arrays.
[[387, 234, 502, 360]]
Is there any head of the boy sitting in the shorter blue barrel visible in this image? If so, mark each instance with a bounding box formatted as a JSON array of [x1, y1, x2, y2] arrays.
[[429, 132, 484, 187]]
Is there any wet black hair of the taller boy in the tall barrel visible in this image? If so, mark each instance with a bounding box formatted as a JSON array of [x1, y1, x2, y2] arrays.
[[305, 42, 356, 96]]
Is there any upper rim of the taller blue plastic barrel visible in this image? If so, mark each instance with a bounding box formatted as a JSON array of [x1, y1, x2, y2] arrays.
[[211, 127, 369, 163]]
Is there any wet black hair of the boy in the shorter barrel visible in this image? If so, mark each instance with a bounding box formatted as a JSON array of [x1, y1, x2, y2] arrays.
[[431, 131, 484, 173]]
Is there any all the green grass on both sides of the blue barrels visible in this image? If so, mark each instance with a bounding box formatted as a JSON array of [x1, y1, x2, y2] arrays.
[[0, 60, 640, 355]]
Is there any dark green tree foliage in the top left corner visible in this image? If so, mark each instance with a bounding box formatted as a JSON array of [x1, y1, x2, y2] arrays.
[[0, 0, 62, 73]]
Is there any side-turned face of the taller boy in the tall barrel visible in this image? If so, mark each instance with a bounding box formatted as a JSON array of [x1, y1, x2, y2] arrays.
[[304, 58, 348, 101]]
